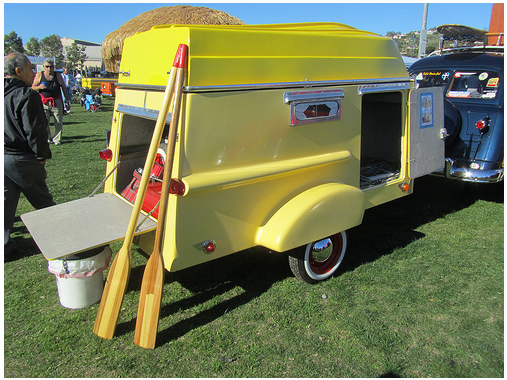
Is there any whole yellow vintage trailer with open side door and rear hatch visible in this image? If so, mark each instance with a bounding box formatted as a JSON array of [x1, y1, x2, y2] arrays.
[[22, 23, 445, 283]]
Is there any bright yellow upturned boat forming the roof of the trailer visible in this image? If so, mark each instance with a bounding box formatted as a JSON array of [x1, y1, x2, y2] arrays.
[[119, 23, 407, 86]]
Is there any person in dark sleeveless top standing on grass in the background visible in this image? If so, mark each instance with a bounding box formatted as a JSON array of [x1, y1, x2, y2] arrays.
[[32, 59, 70, 145]]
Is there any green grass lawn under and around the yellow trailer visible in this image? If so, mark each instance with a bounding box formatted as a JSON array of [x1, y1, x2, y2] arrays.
[[4, 99, 504, 377]]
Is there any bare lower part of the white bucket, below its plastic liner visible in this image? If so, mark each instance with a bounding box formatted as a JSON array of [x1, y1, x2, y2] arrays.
[[56, 272, 104, 309]]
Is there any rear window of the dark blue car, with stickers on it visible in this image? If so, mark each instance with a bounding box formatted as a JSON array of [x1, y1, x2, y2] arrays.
[[445, 70, 500, 99]]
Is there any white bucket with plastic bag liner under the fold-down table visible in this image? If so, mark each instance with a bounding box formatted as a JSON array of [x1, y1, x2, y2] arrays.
[[48, 246, 112, 309]]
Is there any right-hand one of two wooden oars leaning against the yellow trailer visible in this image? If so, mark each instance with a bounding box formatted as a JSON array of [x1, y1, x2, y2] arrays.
[[134, 45, 187, 349]]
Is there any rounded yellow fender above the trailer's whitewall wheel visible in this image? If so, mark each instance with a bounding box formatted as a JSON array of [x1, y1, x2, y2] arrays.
[[257, 182, 365, 252]]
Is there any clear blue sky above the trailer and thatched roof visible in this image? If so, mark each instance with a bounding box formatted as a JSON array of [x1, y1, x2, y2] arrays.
[[4, 1, 492, 43]]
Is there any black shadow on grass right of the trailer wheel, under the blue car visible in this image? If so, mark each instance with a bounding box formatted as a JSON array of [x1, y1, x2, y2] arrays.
[[341, 176, 504, 273]]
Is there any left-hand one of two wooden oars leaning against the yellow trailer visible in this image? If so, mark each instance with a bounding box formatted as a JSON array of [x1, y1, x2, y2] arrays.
[[93, 44, 182, 339]]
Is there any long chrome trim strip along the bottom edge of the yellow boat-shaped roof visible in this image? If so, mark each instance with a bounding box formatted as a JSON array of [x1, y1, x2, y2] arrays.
[[116, 77, 415, 92]]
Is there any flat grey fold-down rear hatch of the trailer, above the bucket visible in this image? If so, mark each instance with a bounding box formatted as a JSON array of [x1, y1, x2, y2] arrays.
[[21, 193, 156, 260]]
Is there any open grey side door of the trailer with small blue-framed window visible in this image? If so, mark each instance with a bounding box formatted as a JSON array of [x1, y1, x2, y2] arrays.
[[409, 87, 446, 178]]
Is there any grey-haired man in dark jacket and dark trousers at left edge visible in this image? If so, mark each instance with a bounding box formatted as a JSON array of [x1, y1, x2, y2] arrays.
[[4, 53, 55, 257]]
